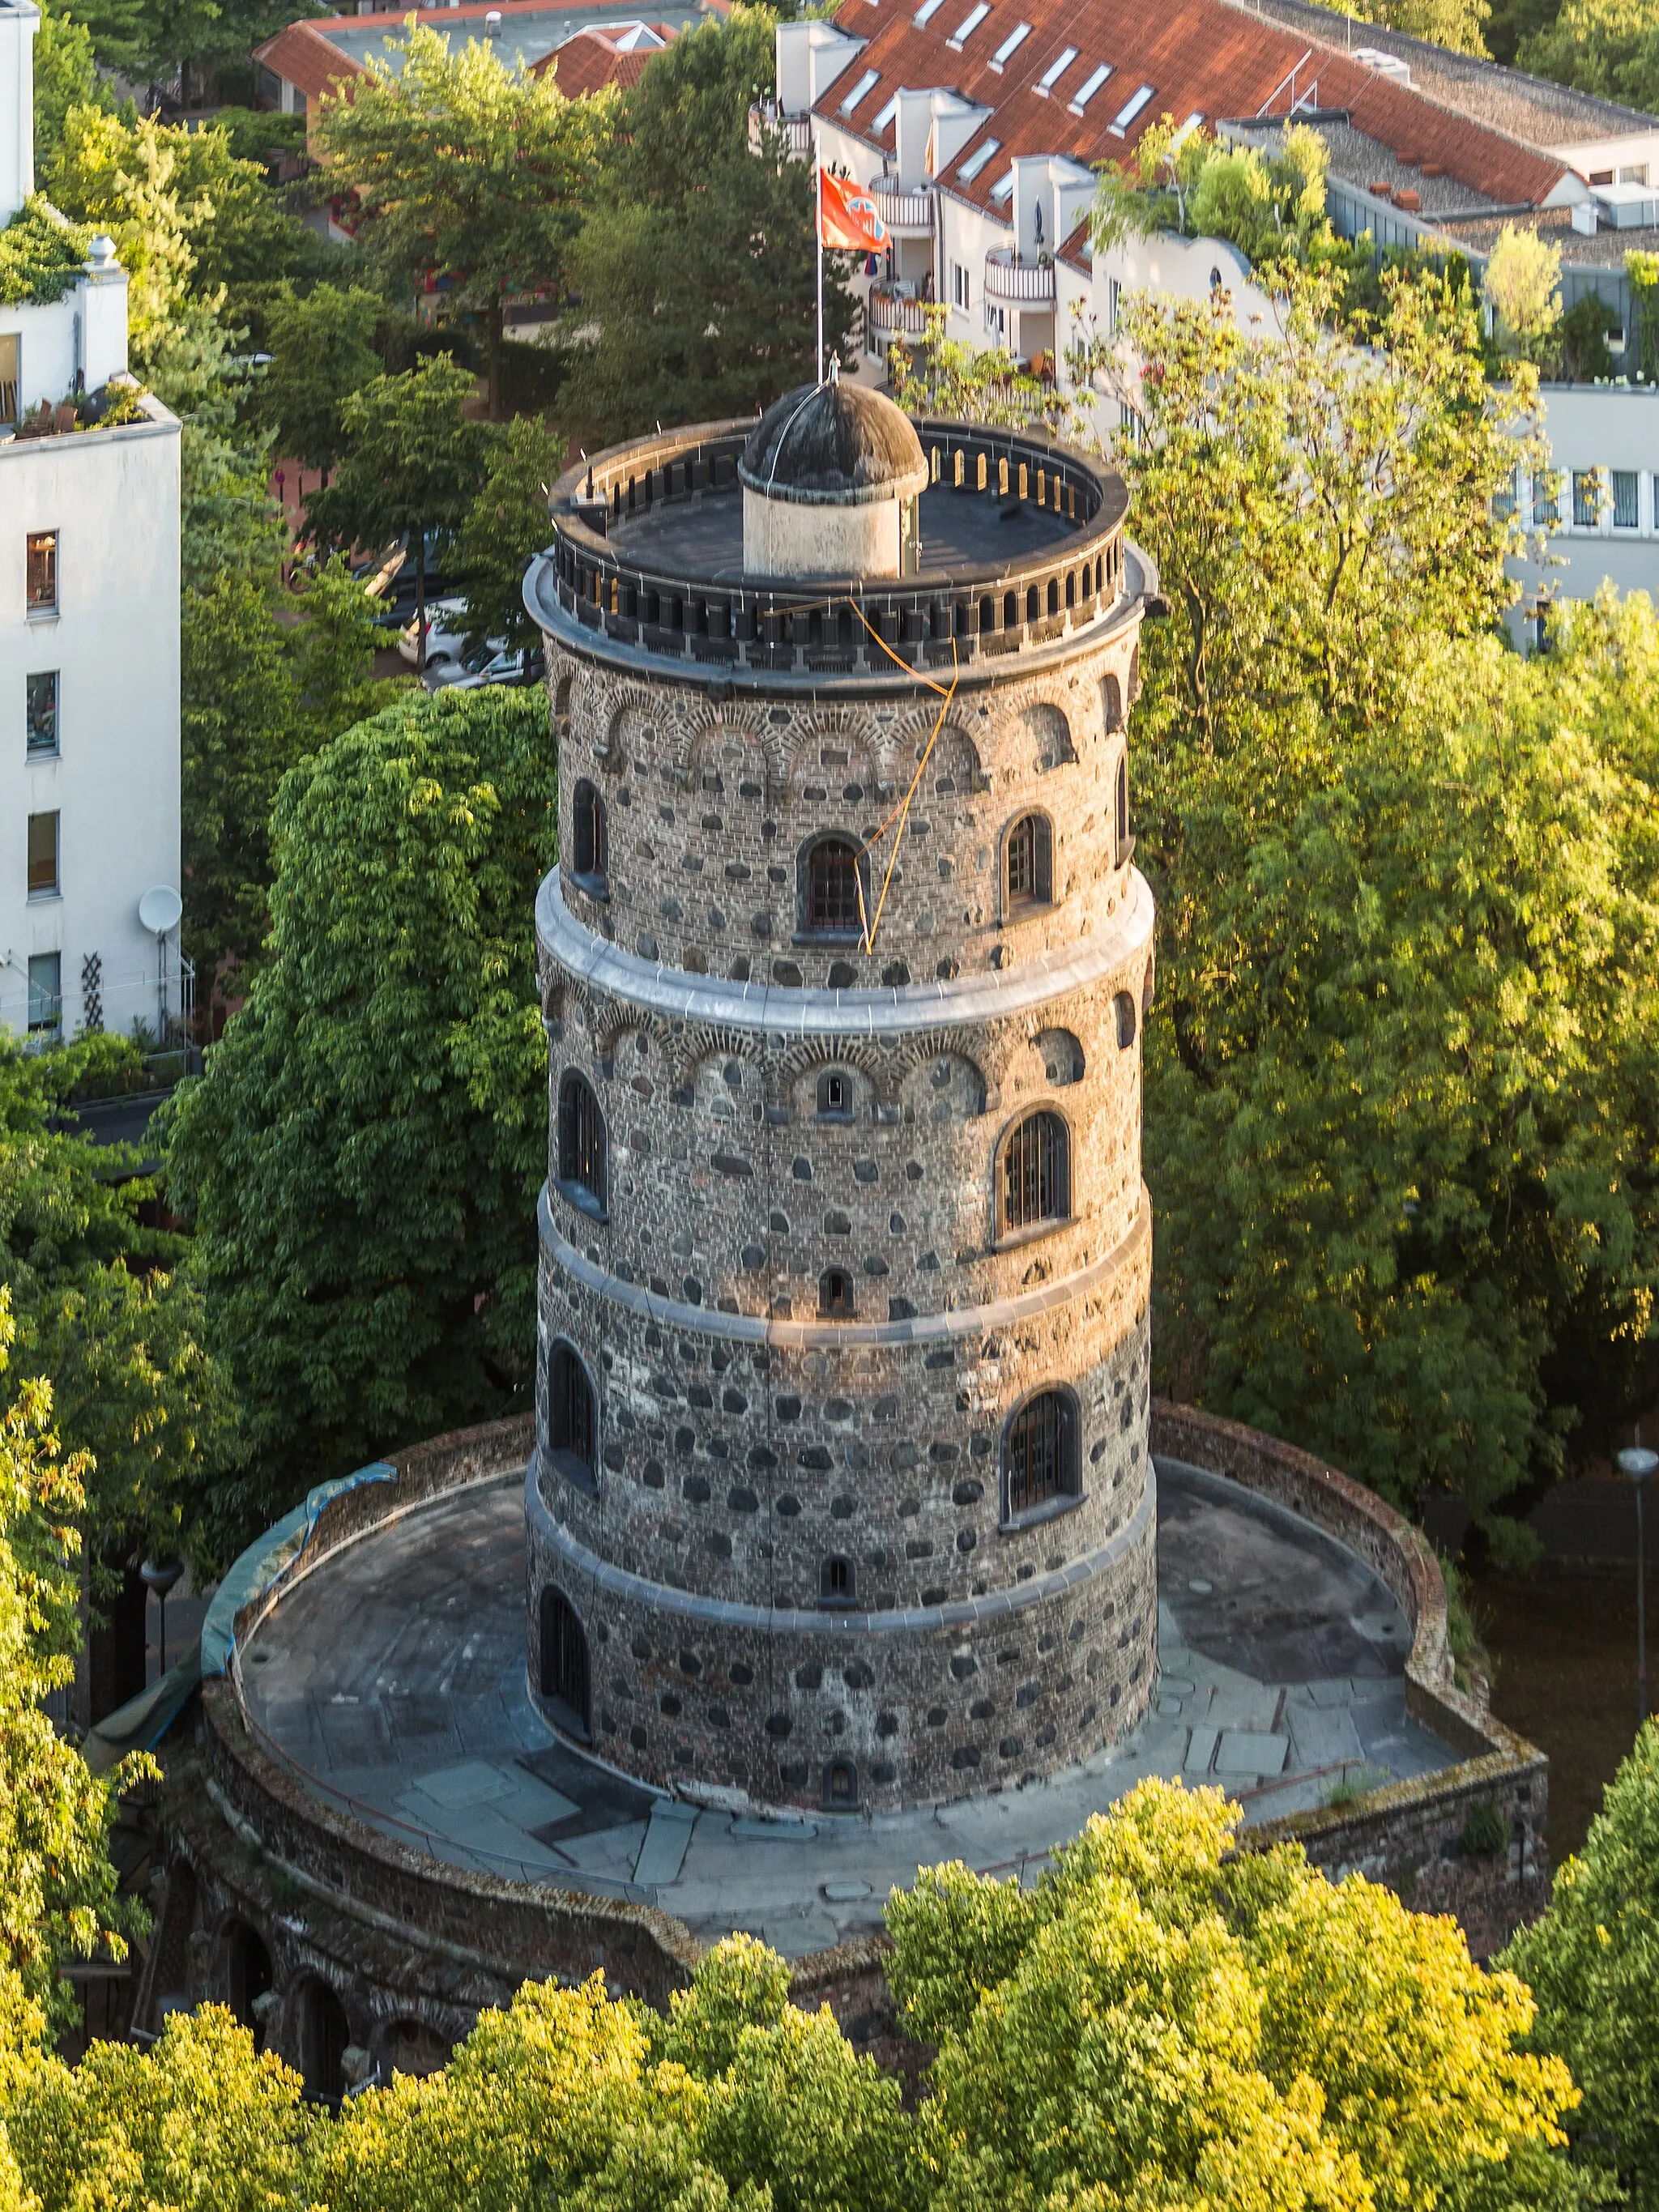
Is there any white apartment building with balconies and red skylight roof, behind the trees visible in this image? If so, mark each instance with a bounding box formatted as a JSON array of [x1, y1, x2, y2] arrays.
[[776, 0, 1659, 624]]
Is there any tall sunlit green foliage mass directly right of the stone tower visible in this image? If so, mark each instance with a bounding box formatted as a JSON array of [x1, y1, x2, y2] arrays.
[[1121, 276, 1655, 1537]]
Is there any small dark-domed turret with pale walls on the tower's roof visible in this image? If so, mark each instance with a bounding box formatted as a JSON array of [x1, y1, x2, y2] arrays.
[[736, 374, 927, 578]]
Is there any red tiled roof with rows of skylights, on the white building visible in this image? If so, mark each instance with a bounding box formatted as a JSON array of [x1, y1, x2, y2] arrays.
[[818, 0, 1564, 208]]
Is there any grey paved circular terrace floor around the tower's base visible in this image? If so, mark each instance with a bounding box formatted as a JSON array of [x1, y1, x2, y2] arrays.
[[241, 1460, 1456, 1958]]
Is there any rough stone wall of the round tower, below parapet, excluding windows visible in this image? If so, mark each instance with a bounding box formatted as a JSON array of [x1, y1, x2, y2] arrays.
[[527, 416, 1157, 1809]]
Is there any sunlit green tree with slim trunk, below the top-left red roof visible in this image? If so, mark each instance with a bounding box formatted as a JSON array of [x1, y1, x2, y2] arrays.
[[316, 24, 615, 418]]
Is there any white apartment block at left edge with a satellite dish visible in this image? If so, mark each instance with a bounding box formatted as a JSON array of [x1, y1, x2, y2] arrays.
[[0, 0, 181, 1042]]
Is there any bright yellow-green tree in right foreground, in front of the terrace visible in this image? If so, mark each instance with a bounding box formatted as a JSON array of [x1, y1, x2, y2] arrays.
[[887, 1783, 1575, 2212]]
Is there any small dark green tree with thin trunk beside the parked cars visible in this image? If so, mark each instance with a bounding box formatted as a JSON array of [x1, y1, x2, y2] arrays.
[[308, 354, 488, 666]]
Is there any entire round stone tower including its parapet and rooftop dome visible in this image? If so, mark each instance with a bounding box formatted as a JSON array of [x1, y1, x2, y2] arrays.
[[524, 382, 1157, 1812]]
